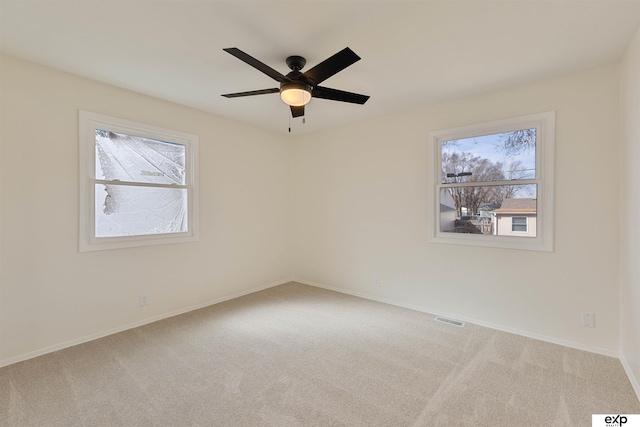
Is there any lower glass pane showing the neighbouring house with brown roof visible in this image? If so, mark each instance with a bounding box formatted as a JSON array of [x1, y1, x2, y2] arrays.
[[440, 184, 538, 237]]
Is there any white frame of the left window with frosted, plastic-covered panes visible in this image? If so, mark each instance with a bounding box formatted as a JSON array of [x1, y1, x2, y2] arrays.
[[78, 110, 199, 252]]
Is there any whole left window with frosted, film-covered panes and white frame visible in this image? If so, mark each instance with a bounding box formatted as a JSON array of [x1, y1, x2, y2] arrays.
[[79, 111, 198, 252]]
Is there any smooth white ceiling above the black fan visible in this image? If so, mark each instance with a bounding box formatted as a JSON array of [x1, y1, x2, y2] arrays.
[[0, 0, 640, 134]]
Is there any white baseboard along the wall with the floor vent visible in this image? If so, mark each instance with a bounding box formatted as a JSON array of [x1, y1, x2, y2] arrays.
[[292, 277, 620, 359]]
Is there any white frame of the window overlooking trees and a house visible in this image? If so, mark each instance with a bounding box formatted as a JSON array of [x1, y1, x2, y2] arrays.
[[427, 111, 555, 252]]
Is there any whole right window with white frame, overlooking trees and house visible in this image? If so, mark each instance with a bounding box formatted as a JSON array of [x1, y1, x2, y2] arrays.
[[428, 112, 555, 251]]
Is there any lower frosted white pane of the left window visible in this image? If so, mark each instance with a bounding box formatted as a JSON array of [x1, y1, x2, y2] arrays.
[[95, 184, 187, 237]]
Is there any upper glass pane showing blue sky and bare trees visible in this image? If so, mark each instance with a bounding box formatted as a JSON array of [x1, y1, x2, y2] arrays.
[[441, 128, 536, 183]]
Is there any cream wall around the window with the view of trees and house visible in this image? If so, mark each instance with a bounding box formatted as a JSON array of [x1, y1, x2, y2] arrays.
[[293, 65, 619, 354]]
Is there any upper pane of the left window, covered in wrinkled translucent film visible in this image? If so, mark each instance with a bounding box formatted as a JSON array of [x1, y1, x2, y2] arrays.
[[95, 130, 186, 185]]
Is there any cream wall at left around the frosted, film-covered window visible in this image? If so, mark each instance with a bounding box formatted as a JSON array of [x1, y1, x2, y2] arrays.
[[0, 57, 291, 366]]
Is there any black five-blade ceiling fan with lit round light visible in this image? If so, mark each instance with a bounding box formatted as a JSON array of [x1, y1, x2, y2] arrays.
[[222, 47, 369, 117]]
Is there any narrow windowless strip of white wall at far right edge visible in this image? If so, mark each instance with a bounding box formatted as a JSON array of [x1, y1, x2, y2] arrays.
[[620, 24, 640, 396]]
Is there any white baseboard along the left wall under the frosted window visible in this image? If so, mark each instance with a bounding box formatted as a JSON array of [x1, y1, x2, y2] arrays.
[[0, 279, 292, 368]]
